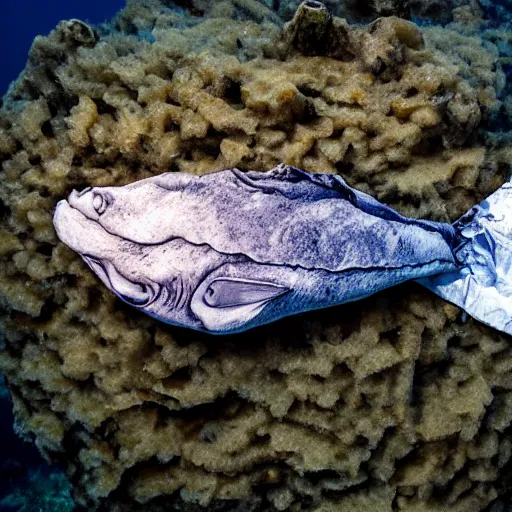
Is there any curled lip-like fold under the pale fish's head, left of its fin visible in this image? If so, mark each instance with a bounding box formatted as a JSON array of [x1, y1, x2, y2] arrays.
[[81, 255, 162, 308]]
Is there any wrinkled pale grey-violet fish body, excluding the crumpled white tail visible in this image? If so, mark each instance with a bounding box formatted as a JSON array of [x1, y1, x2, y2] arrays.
[[54, 164, 457, 334]]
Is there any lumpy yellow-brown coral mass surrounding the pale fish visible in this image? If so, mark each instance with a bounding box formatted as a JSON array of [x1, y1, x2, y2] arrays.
[[0, 0, 512, 512]]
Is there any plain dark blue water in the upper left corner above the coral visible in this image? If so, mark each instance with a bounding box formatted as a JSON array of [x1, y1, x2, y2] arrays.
[[0, 0, 125, 97]]
